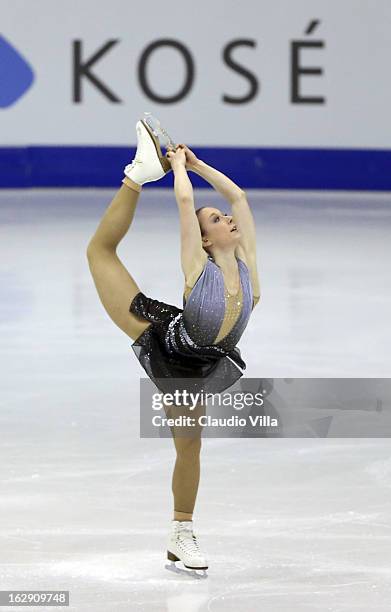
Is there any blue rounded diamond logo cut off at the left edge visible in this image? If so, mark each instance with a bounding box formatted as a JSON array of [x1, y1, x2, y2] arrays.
[[0, 36, 34, 108]]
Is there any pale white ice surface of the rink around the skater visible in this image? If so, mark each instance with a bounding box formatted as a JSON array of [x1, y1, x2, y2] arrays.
[[0, 189, 391, 612]]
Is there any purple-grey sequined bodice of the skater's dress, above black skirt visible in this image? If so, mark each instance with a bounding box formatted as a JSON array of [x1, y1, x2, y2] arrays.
[[183, 257, 253, 350]]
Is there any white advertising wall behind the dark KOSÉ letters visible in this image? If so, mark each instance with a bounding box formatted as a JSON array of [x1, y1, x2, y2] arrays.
[[0, 0, 391, 148]]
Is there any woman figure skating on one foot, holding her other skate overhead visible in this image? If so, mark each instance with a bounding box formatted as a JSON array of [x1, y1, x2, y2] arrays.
[[87, 121, 260, 570]]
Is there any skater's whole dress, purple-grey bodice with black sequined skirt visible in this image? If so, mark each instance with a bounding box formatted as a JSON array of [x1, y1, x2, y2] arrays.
[[129, 256, 253, 393]]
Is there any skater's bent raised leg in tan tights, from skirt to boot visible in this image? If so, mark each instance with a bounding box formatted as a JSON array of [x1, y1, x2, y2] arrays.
[[87, 178, 150, 340]]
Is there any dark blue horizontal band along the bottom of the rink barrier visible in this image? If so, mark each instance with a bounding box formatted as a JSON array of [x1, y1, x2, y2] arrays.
[[0, 146, 391, 191]]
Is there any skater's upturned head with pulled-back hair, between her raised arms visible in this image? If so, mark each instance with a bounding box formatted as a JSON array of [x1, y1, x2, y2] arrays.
[[198, 206, 239, 248]]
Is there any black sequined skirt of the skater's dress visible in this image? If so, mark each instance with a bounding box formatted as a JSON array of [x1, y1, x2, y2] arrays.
[[129, 292, 246, 393]]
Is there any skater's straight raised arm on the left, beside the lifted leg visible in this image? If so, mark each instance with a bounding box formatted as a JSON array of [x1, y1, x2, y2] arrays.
[[171, 154, 207, 287]]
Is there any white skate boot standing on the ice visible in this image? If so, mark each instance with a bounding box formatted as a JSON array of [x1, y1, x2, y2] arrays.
[[165, 521, 208, 578]]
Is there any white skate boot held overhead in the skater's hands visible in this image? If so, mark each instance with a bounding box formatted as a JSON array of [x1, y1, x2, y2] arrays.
[[124, 120, 171, 185]]
